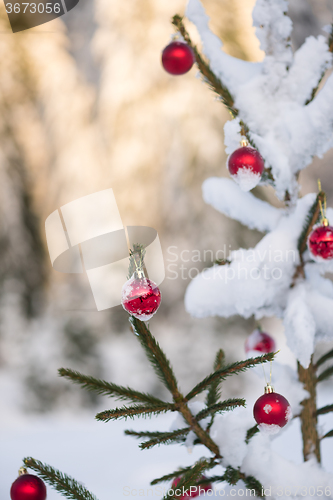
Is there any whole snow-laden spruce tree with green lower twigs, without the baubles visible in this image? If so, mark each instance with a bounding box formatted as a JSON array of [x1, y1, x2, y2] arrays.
[[14, 0, 333, 500]]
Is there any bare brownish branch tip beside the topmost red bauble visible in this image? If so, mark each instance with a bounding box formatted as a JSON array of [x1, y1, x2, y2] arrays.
[[172, 14, 238, 118]]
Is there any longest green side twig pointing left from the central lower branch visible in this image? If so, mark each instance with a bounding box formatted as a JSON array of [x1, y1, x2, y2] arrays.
[[59, 368, 165, 405]]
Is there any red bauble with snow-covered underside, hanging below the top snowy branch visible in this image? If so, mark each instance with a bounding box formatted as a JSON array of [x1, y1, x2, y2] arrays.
[[228, 146, 265, 191]]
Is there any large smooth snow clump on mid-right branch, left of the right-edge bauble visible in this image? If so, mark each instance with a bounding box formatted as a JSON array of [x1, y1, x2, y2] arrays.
[[185, 195, 314, 318]]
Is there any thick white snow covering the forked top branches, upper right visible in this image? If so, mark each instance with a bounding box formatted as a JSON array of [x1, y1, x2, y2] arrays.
[[186, 0, 333, 204]]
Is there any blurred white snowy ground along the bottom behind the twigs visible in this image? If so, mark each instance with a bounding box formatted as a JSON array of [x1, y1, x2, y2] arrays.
[[0, 406, 333, 500]]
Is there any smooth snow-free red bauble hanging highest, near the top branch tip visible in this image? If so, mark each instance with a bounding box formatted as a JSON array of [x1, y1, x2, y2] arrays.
[[162, 42, 195, 75]]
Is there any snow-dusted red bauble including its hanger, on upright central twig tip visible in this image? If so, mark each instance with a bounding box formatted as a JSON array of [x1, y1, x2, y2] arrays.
[[121, 245, 162, 321]]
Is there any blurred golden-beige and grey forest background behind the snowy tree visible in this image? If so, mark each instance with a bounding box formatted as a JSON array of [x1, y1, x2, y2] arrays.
[[0, 0, 333, 411]]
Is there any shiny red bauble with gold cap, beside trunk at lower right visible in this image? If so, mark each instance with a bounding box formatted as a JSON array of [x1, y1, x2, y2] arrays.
[[253, 384, 292, 434]]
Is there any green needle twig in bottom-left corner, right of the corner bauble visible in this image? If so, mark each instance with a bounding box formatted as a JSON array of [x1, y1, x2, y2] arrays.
[[23, 457, 97, 500]]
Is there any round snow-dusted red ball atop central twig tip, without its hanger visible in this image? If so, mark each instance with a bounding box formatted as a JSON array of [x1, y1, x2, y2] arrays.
[[121, 276, 161, 321]]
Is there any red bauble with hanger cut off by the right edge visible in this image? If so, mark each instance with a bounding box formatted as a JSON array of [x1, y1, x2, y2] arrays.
[[308, 181, 333, 262]]
